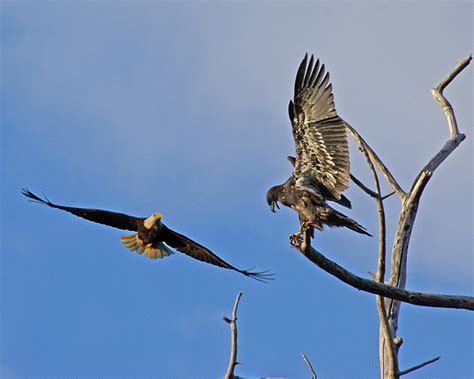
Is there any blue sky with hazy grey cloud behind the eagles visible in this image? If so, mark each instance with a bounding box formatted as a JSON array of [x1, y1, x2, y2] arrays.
[[0, 1, 474, 378]]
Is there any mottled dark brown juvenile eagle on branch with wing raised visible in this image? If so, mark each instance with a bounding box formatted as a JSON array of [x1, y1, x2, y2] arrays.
[[266, 54, 370, 244]]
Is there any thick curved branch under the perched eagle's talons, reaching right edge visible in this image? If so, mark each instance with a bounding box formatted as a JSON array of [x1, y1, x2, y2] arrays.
[[300, 244, 474, 311]]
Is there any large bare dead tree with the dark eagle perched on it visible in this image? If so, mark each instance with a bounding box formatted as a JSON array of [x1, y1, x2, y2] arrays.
[[292, 55, 474, 379]]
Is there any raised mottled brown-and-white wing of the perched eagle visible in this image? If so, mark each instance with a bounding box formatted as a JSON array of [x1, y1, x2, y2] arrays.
[[289, 55, 349, 199]]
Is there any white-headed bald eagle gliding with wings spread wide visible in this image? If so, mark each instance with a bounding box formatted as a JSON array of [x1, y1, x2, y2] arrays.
[[22, 188, 273, 282]]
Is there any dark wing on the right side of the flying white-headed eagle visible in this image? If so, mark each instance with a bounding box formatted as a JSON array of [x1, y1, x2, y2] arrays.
[[161, 225, 273, 282]]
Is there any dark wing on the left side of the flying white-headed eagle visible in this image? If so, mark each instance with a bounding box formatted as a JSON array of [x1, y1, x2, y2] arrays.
[[22, 188, 144, 231]]
